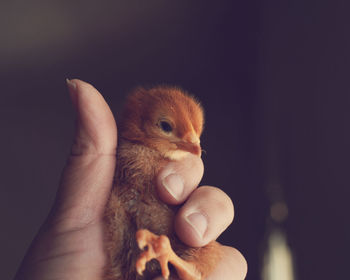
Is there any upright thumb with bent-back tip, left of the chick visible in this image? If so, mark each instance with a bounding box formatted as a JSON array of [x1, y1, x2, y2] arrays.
[[49, 79, 117, 228]]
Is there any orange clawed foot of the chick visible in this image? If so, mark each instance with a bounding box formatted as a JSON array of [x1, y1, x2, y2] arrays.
[[136, 229, 202, 280]]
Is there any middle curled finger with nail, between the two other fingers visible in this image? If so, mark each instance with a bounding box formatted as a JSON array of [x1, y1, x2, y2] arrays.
[[175, 186, 234, 247]]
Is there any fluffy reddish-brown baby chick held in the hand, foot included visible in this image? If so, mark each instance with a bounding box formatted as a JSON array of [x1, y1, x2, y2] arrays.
[[105, 86, 221, 280]]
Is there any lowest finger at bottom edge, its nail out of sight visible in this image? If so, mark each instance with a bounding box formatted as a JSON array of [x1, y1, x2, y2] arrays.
[[206, 246, 247, 280]]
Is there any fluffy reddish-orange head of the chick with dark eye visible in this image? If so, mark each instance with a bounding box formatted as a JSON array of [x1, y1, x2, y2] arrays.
[[119, 86, 204, 160]]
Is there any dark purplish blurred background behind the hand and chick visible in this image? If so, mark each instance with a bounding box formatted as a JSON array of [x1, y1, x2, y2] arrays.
[[0, 0, 350, 280]]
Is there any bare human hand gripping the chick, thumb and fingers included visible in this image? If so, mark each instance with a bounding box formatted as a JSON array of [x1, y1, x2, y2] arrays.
[[15, 80, 247, 280]]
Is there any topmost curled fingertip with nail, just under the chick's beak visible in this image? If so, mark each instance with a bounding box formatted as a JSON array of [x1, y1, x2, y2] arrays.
[[157, 154, 204, 204]]
